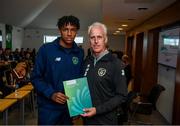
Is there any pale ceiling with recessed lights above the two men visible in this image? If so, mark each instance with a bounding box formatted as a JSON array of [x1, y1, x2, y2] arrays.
[[0, 0, 176, 34]]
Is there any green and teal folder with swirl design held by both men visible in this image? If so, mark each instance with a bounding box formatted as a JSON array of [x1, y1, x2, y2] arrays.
[[63, 77, 92, 117]]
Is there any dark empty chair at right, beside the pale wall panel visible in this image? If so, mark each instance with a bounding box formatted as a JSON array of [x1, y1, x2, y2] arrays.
[[130, 84, 165, 124]]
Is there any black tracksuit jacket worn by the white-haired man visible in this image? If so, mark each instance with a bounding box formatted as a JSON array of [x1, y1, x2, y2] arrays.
[[84, 53, 127, 125]]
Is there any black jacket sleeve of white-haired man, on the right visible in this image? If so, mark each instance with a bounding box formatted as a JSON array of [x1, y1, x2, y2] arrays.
[[96, 60, 127, 114]]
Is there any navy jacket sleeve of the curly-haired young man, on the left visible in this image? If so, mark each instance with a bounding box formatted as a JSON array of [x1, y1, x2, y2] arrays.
[[31, 45, 55, 98]]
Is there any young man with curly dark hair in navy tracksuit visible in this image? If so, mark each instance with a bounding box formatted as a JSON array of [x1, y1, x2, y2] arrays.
[[31, 16, 84, 125]]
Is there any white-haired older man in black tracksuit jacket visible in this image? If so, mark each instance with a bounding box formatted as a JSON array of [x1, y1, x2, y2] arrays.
[[82, 22, 127, 125]]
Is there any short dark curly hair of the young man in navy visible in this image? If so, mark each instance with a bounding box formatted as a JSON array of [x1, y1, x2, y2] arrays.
[[57, 15, 80, 30]]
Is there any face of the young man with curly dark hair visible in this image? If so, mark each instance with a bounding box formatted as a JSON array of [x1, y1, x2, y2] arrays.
[[59, 24, 77, 45]]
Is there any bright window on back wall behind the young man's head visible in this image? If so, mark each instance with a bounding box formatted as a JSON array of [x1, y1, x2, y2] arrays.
[[44, 35, 83, 43]]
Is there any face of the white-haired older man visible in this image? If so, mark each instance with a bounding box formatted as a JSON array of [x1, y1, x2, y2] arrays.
[[89, 26, 107, 55]]
